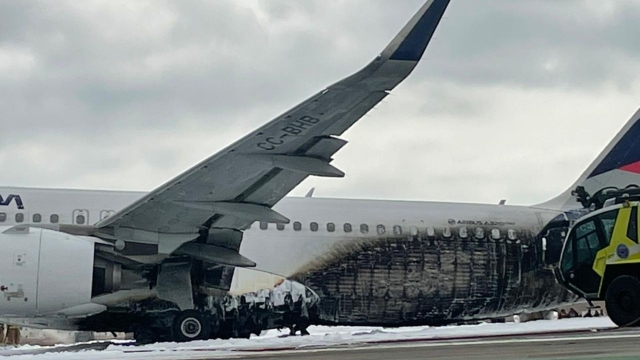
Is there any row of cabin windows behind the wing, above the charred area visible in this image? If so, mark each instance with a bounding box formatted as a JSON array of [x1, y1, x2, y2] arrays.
[[260, 221, 517, 240]]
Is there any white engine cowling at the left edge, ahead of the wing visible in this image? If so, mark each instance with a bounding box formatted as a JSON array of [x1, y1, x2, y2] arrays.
[[0, 225, 96, 317]]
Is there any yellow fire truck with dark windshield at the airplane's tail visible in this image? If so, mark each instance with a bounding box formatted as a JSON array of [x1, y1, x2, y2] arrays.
[[555, 196, 640, 326]]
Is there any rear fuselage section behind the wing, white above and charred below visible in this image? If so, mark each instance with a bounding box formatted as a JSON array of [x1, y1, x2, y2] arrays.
[[236, 200, 577, 326]]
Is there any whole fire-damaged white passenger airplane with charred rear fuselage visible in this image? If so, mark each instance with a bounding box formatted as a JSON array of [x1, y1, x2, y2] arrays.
[[0, 0, 640, 343]]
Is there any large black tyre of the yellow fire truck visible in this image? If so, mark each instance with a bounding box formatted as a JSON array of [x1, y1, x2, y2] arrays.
[[605, 275, 640, 327]]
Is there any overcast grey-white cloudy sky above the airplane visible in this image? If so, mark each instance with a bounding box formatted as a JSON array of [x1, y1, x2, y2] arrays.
[[0, 0, 640, 204]]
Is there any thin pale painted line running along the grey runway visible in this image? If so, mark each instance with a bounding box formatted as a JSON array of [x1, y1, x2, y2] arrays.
[[221, 334, 640, 358]]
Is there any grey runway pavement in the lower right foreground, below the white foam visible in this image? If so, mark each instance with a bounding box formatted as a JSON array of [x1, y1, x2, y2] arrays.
[[228, 329, 640, 360]]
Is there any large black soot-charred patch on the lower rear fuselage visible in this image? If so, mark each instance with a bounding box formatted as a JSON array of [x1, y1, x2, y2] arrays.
[[291, 229, 576, 326]]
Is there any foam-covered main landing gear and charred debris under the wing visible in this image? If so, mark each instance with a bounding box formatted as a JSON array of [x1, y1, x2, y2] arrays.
[[127, 278, 319, 344]]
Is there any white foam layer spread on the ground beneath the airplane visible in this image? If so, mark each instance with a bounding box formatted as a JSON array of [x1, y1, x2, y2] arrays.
[[0, 317, 615, 360]]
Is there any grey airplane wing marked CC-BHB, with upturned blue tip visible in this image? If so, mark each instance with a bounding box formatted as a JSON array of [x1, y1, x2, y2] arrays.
[[96, 0, 449, 263]]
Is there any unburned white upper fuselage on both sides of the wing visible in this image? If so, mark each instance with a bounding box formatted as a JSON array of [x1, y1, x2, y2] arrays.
[[0, 187, 561, 277]]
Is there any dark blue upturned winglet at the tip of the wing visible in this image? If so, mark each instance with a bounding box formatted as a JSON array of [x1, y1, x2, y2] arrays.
[[380, 0, 450, 61]]
